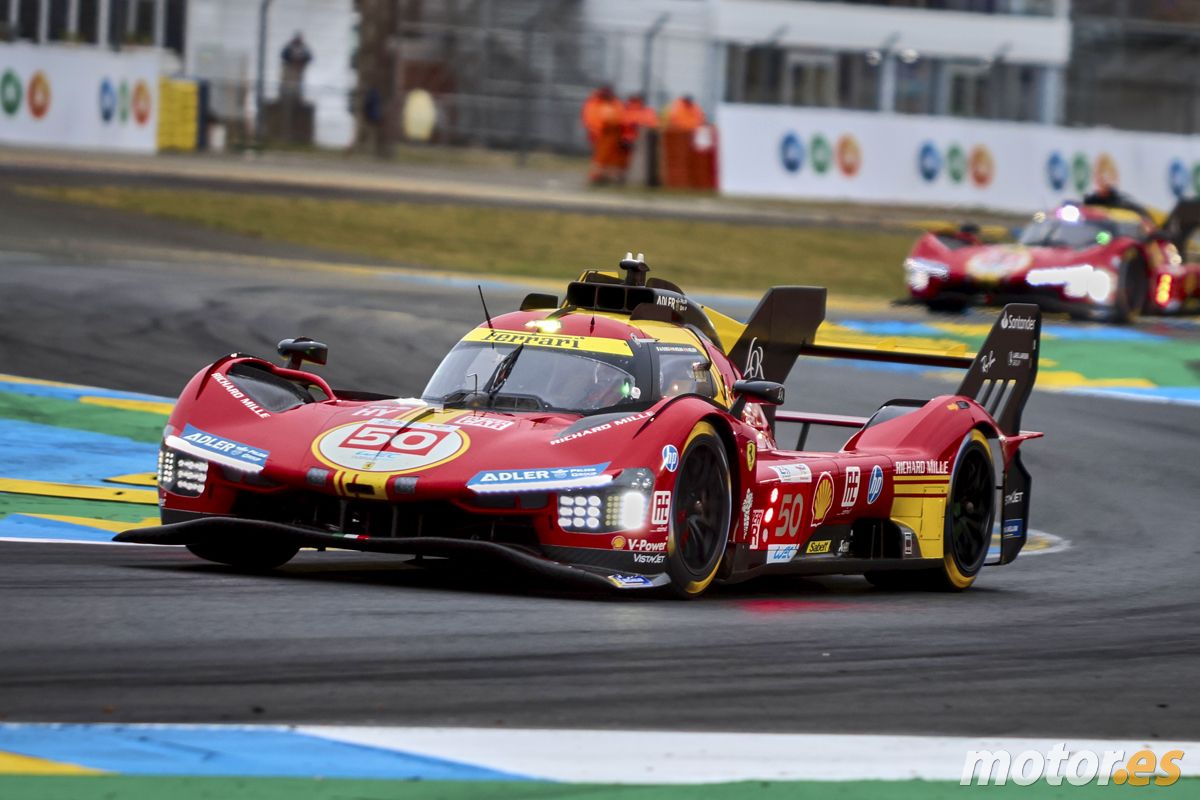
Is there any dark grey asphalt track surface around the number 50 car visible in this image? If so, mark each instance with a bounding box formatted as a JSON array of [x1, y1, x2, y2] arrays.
[[0, 181, 1200, 739]]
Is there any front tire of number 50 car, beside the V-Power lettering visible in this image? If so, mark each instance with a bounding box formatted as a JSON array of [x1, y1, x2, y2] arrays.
[[666, 422, 733, 597]]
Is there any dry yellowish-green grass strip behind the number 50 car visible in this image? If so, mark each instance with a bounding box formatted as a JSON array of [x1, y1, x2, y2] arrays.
[[20, 187, 914, 297]]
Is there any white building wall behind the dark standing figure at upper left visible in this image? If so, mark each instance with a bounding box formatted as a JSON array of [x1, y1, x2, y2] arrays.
[[184, 0, 358, 148]]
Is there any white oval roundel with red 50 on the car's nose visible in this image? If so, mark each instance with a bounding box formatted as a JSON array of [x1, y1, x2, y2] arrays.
[[314, 422, 469, 473]]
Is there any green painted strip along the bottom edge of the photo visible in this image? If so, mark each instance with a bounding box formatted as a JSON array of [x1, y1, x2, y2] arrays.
[[0, 776, 1200, 800]]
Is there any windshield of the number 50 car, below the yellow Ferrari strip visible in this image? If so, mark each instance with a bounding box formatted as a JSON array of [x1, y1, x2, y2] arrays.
[[421, 342, 650, 414]]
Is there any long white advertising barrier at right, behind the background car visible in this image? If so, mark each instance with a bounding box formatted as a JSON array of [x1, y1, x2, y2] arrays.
[[718, 104, 1200, 212]]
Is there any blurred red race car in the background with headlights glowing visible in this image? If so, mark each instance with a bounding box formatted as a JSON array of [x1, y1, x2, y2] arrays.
[[904, 192, 1200, 323]]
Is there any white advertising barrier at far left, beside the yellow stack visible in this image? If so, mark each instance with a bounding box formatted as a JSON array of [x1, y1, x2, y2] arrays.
[[0, 43, 158, 152]]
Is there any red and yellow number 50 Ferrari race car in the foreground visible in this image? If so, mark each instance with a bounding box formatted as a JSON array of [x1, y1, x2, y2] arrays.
[[116, 257, 1042, 596]]
